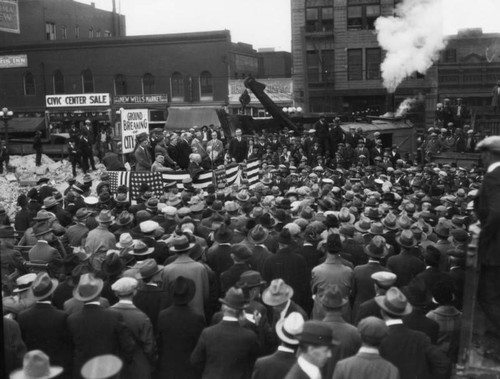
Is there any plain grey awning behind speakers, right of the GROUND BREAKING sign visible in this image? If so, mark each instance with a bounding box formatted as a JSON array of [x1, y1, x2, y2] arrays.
[[165, 107, 220, 130]]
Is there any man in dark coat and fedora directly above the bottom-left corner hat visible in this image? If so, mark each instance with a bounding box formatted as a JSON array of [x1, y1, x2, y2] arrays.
[[17, 272, 72, 378]]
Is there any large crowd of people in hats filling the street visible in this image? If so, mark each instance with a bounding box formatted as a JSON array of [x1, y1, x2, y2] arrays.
[[0, 102, 500, 379]]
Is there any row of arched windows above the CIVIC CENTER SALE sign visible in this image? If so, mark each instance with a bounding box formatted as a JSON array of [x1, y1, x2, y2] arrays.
[[23, 69, 213, 101]]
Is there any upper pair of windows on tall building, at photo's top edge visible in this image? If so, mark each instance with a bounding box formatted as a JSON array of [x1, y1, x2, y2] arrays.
[[305, 0, 380, 33]]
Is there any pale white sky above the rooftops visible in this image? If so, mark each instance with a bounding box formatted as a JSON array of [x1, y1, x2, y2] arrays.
[[78, 0, 500, 51]]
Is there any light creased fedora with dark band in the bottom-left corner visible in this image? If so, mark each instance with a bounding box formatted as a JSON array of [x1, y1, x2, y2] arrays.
[[9, 350, 64, 379]]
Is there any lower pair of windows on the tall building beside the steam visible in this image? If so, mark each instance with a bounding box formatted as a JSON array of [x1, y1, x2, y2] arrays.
[[306, 48, 382, 83]]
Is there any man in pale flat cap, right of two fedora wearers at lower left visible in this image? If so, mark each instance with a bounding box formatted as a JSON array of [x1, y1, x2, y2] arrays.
[[111, 277, 158, 379]]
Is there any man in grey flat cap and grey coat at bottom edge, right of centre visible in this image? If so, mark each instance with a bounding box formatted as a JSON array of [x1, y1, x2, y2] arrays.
[[333, 317, 399, 379]]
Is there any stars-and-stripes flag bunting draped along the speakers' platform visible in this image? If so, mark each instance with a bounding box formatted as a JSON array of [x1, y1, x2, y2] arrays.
[[108, 160, 260, 200]]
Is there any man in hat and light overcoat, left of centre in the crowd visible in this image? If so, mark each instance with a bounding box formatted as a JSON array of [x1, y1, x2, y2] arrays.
[[161, 235, 209, 316]]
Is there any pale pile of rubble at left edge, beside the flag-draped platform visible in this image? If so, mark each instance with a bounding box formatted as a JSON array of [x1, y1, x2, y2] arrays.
[[0, 154, 105, 221]]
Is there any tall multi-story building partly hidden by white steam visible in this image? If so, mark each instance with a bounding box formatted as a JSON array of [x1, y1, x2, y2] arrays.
[[291, 0, 436, 126]]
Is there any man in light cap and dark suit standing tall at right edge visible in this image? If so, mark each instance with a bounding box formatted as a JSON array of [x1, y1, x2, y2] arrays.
[[476, 136, 500, 356]]
